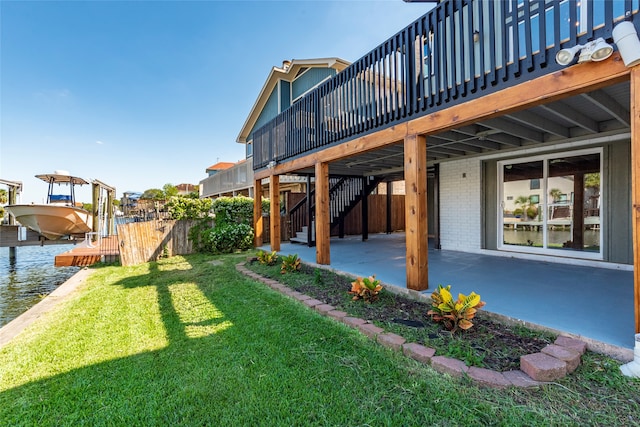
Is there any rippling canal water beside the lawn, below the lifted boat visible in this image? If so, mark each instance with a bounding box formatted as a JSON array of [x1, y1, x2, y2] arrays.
[[0, 245, 80, 327]]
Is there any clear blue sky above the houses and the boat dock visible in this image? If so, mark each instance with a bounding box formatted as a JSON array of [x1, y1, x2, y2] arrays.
[[0, 0, 431, 203]]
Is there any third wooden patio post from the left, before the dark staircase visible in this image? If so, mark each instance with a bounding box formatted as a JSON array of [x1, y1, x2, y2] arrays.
[[316, 162, 331, 265]]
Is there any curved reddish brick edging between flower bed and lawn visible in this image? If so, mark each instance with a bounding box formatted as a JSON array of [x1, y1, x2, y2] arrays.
[[236, 262, 587, 388]]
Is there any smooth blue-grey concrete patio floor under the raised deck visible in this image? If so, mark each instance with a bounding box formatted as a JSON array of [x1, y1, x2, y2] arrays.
[[262, 233, 635, 357]]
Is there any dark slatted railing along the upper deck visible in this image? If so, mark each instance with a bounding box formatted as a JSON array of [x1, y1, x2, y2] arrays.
[[253, 0, 640, 170]]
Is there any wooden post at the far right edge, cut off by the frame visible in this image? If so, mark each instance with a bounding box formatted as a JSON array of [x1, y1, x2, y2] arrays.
[[630, 65, 640, 334]]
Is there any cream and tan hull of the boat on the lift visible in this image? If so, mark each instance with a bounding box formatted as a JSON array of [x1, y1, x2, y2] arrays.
[[7, 205, 93, 240]]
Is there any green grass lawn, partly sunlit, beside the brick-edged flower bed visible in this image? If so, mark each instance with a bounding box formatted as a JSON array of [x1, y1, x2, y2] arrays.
[[0, 255, 640, 426]]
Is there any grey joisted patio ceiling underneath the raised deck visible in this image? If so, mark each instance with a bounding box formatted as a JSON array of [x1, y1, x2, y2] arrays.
[[299, 82, 630, 180]]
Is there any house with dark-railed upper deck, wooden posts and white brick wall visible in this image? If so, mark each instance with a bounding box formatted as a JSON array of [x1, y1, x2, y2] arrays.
[[250, 0, 640, 320]]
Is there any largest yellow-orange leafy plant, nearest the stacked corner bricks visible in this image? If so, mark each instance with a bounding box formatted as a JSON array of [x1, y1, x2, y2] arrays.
[[427, 285, 485, 332]]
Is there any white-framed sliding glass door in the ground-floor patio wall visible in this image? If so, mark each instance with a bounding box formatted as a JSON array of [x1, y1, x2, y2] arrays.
[[498, 149, 603, 258]]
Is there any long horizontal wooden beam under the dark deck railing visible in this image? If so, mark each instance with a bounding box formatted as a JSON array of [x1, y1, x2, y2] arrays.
[[255, 52, 630, 179]]
